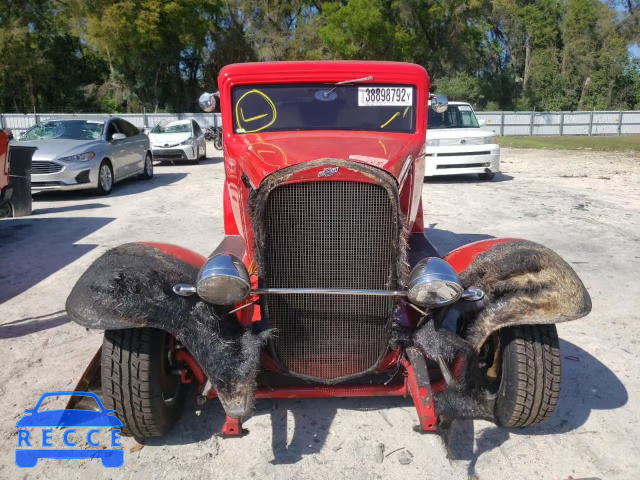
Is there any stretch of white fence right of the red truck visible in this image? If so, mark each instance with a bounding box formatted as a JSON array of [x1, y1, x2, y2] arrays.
[[476, 110, 640, 136]]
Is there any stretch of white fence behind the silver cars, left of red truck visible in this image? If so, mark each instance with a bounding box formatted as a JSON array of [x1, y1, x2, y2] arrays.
[[0, 113, 222, 133]]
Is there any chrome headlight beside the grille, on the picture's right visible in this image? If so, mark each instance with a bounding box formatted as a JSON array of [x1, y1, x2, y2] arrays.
[[407, 257, 463, 307]]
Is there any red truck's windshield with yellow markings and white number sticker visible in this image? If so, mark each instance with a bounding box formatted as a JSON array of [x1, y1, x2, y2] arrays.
[[231, 84, 416, 134]]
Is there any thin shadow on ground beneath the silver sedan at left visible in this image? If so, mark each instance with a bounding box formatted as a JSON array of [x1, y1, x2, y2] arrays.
[[33, 171, 187, 203]]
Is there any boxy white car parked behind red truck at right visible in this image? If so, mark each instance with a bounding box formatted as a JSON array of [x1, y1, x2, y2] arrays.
[[425, 102, 500, 180]]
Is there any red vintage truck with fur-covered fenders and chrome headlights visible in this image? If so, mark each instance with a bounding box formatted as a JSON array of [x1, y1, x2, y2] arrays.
[[66, 61, 591, 437]]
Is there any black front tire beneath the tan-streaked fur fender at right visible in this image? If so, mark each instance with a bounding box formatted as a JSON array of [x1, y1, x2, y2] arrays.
[[495, 325, 561, 427]]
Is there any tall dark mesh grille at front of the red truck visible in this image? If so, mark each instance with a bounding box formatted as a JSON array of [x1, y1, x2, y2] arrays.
[[263, 181, 398, 380]]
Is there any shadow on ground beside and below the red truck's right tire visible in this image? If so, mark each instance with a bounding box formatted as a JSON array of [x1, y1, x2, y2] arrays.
[[447, 339, 629, 477]]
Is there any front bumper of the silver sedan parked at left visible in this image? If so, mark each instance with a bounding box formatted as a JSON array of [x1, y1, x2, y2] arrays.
[[31, 159, 99, 192]]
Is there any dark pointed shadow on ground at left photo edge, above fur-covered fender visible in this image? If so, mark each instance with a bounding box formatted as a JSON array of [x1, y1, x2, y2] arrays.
[[0, 217, 114, 303]]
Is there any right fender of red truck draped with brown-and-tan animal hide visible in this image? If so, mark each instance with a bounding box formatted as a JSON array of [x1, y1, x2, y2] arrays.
[[444, 239, 591, 350]]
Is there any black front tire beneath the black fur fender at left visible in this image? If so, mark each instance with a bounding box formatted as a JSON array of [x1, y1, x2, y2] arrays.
[[102, 328, 185, 437]]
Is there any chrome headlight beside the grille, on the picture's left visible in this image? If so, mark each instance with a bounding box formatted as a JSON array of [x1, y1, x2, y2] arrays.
[[196, 253, 251, 305]]
